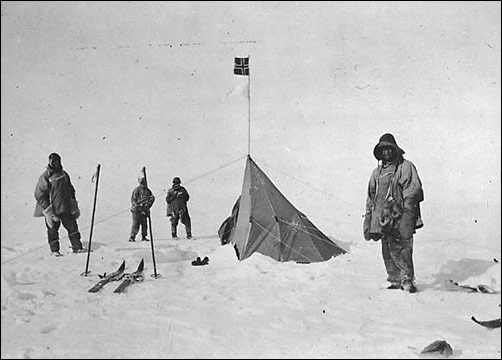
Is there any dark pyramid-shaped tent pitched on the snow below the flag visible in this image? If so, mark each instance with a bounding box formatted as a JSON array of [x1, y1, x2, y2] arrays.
[[218, 155, 346, 263]]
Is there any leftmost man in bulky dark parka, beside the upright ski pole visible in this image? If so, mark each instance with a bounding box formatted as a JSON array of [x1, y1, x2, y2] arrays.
[[33, 153, 86, 256]]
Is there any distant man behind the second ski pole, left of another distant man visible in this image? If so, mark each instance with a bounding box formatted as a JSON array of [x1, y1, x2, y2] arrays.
[[129, 174, 155, 241]]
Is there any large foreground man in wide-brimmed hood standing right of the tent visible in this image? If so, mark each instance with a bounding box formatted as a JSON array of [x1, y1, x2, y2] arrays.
[[363, 133, 424, 293]]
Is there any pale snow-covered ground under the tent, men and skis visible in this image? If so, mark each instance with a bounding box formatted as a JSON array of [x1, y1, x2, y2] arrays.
[[2, 232, 501, 359]]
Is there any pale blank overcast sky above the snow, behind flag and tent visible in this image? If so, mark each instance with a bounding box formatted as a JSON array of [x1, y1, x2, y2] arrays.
[[1, 1, 501, 249]]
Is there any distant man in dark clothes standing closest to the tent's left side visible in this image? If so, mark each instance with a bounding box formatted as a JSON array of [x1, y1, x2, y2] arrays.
[[166, 177, 192, 239]]
